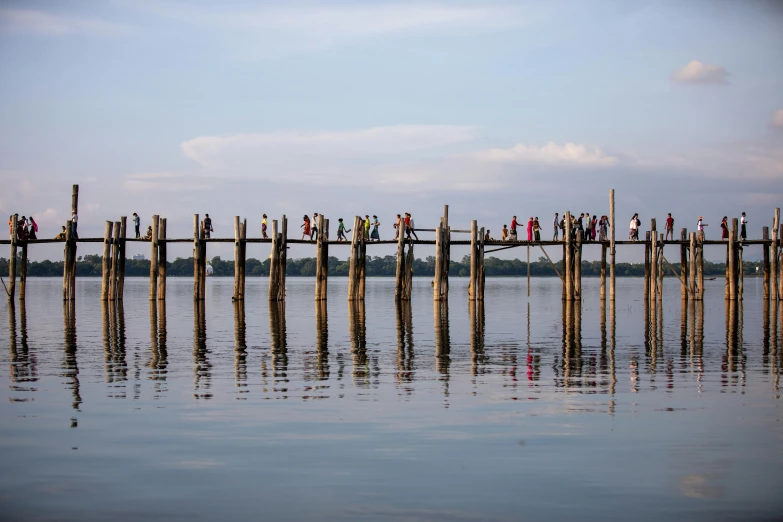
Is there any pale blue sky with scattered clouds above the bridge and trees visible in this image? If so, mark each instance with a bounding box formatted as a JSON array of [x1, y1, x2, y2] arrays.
[[0, 0, 783, 262]]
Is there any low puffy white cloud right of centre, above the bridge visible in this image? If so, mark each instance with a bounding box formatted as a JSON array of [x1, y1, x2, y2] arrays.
[[474, 141, 619, 167]]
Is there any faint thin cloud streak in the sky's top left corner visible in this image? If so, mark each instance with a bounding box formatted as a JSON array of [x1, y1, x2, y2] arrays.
[[0, 9, 128, 36]]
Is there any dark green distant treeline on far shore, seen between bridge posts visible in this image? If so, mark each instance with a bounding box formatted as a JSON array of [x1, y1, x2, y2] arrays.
[[0, 255, 761, 277]]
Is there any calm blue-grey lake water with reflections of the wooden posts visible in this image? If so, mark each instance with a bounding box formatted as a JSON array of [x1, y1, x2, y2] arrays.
[[0, 278, 783, 521]]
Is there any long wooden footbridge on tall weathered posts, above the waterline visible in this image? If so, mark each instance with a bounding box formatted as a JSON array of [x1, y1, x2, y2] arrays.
[[6, 185, 783, 303]]
